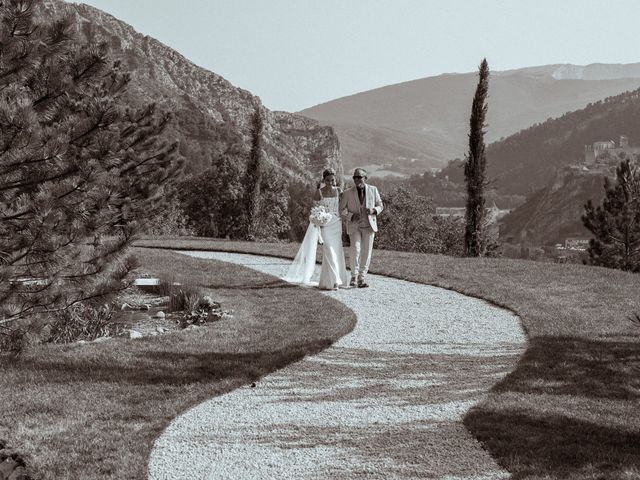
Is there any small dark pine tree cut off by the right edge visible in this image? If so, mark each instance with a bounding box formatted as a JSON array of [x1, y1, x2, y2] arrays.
[[582, 160, 640, 272]]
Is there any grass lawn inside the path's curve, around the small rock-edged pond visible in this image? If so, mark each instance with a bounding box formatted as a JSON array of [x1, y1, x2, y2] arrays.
[[0, 249, 355, 480]]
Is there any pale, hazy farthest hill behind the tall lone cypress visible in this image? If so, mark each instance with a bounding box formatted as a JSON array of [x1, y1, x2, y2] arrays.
[[299, 64, 640, 173]]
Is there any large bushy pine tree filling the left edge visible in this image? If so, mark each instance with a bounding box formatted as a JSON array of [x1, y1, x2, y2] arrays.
[[0, 0, 178, 324]]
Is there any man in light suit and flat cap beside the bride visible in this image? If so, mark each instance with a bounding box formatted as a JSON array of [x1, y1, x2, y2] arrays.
[[340, 168, 384, 288]]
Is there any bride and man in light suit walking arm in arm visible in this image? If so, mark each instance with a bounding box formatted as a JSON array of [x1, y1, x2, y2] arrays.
[[285, 168, 383, 290]]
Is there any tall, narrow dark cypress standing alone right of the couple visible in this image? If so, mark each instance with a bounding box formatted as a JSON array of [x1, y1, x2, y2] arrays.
[[464, 58, 489, 257]]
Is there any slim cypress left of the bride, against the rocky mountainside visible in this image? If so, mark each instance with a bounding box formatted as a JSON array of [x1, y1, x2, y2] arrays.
[[245, 105, 263, 240]]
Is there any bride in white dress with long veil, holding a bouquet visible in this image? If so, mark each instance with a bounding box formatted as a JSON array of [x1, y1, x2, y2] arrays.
[[284, 169, 349, 290]]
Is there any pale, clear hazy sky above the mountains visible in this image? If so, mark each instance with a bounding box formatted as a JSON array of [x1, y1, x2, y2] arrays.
[[69, 0, 640, 111]]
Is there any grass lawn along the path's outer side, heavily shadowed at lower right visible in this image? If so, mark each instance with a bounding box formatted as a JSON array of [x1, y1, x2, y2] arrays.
[[138, 238, 640, 480]]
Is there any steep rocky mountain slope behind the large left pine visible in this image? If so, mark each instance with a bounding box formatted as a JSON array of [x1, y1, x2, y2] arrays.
[[43, 0, 342, 179]]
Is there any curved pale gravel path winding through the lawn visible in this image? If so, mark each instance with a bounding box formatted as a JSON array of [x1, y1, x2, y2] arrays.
[[149, 252, 526, 480]]
